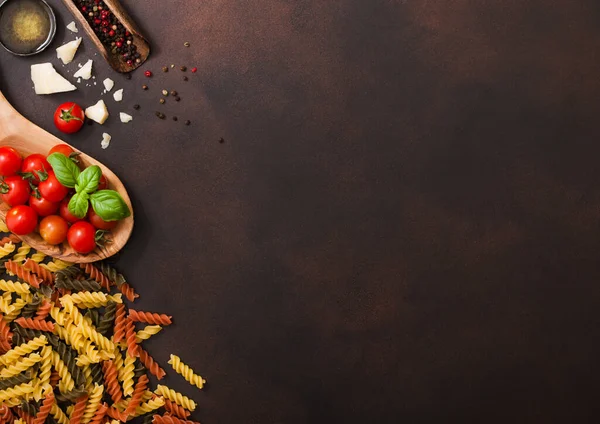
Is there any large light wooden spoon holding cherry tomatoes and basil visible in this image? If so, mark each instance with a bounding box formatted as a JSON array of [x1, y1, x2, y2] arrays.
[[0, 92, 133, 263]]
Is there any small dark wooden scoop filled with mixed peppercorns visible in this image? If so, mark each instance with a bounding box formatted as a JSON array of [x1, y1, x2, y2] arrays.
[[62, 0, 150, 72]]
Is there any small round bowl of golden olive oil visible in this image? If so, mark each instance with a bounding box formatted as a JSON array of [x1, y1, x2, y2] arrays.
[[0, 0, 56, 56]]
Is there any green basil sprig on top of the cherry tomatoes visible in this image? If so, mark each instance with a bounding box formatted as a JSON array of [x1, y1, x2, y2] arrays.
[[48, 153, 131, 221]]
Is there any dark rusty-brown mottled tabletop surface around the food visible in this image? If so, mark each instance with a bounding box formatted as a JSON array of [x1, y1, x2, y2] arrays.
[[0, 0, 600, 424]]
